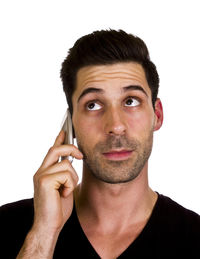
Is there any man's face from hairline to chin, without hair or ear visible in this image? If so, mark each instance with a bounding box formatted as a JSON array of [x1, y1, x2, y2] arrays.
[[72, 62, 159, 183]]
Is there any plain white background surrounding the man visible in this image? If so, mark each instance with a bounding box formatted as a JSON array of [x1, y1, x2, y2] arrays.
[[0, 0, 200, 213]]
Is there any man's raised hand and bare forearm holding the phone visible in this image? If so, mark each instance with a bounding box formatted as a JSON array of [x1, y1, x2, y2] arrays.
[[17, 131, 83, 258]]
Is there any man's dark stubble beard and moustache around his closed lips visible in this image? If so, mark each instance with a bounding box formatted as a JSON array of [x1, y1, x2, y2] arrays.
[[77, 130, 153, 184]]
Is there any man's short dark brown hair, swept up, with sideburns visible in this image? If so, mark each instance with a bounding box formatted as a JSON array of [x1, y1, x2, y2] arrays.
[[60, 29, 159, 114]]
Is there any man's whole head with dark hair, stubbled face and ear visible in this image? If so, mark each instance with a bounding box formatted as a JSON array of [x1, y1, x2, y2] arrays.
[[61, 31, 162, 183]]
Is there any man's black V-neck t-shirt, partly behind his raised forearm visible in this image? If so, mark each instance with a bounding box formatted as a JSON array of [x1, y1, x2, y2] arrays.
[[0, 194, 200, 259]]
